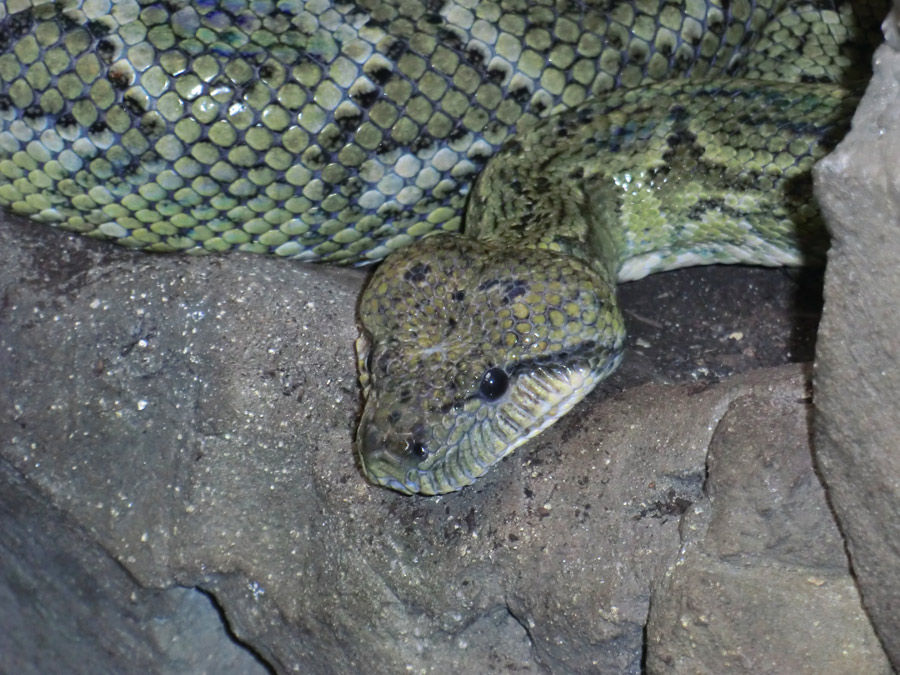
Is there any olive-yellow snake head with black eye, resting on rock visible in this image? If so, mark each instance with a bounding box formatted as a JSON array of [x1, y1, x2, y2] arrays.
[[357, 235, 624, 494]]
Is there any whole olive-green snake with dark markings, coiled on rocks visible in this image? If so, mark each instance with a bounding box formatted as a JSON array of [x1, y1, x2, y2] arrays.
[[0, 0, 887, 495]]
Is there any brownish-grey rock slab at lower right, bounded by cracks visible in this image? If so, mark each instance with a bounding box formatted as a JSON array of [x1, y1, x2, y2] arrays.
[[646, 382, 891, 675]]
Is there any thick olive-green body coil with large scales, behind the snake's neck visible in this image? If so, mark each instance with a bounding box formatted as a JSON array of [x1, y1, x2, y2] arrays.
[[0, 0, 877, 263]]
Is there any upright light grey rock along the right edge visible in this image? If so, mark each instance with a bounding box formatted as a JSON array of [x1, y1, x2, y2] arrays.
[[815, 14, 900, 669]]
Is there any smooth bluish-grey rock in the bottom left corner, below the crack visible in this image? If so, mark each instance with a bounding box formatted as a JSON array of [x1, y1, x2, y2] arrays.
[[0, 460, 267, 675]]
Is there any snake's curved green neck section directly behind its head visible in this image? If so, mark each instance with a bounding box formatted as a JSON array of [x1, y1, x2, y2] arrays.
[[466, 80, 857, 283]]
